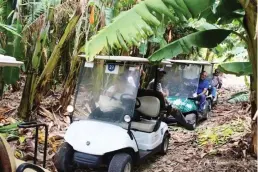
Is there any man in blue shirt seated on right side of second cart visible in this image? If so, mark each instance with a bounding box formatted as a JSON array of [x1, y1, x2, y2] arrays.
[[197, 71, 209, 111]]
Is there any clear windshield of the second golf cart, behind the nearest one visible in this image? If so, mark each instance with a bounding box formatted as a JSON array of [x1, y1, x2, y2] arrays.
[[164, 63, 201, 98]]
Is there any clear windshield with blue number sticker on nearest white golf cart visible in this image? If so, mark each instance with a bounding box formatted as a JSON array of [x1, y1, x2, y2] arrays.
[[73, 60, 140, 123]]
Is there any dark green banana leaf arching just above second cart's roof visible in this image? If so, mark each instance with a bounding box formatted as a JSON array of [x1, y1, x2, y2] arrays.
[[149, 29, 231, 61]]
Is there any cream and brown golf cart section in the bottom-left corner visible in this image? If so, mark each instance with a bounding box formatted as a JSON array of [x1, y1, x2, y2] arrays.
[[0, 135, 49, 172]]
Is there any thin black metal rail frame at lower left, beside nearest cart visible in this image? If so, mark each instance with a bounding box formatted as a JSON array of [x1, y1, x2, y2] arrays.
[[17, 122, 48, 168]]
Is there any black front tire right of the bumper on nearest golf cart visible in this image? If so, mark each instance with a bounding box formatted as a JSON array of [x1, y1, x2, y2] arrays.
[[108, 153, 133, 172]]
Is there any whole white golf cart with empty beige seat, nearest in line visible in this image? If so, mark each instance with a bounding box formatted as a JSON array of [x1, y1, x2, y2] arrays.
[[54, 56, 170, 172]]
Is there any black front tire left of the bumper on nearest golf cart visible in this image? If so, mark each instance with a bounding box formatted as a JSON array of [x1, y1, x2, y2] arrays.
[[53, 142, 74, 172]]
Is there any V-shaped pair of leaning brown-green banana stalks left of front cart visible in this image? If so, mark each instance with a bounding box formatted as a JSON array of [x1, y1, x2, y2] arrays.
[[18, 8, 81, 119]]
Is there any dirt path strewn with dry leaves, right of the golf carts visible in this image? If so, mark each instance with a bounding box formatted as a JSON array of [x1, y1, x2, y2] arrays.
[[135, 76, 257, 172]]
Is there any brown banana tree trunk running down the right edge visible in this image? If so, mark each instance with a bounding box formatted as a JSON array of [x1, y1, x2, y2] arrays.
[[239, 0, 258, 156]]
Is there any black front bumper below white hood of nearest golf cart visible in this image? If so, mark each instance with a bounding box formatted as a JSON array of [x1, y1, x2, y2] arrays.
[[73, 152, 103, 168]]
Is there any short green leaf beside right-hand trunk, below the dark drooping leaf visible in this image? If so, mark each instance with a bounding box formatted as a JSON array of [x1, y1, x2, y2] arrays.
[[218, 62, 253, 76]]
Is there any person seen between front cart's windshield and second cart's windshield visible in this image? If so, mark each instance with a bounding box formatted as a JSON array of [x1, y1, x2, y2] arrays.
[[147, 68, 169, 98]]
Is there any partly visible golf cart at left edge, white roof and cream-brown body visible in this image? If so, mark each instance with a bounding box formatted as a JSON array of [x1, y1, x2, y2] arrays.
[[0, 54, 49, 172]]
